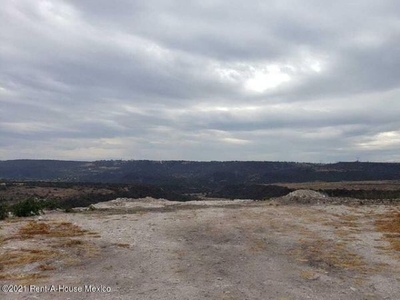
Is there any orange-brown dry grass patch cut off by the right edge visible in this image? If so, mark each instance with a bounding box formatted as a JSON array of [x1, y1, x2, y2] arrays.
[[375, 212, 400, 251]]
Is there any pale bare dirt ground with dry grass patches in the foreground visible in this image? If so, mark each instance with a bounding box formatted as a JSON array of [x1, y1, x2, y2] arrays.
[[0, 199, 400, 300]]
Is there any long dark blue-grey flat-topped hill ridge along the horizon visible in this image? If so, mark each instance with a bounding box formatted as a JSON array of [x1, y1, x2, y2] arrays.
[[0, 160, 400, 190]]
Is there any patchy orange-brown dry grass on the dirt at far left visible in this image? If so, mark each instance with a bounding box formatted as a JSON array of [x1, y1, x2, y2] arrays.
[[0, 221, 99, 281]]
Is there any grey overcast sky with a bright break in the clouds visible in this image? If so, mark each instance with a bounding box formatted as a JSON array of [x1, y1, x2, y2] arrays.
[[0, 0, 400, 162]]
